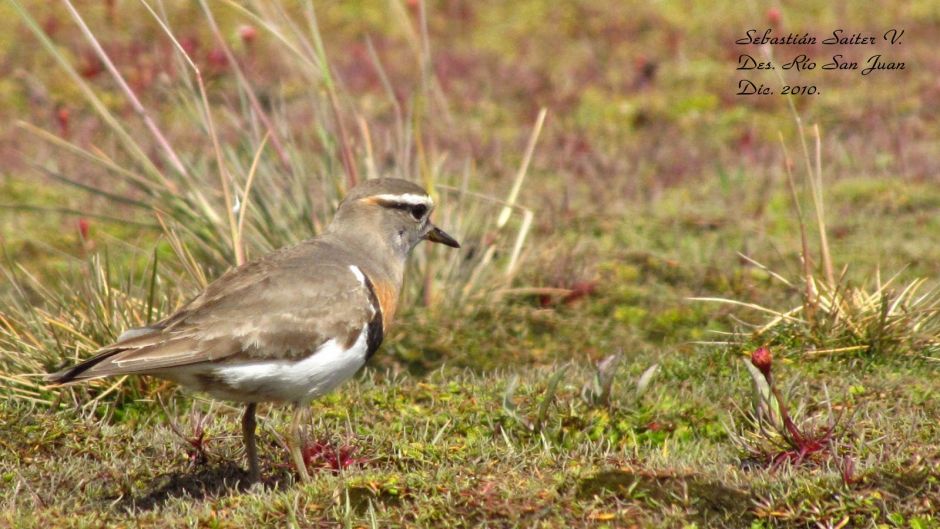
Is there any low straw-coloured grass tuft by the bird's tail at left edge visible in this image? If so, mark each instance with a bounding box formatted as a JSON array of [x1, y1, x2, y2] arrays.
[[0, 252, 167, 411]]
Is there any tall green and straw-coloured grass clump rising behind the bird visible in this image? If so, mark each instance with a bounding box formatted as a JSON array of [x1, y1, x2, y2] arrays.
[[0, 0, 546, 404]]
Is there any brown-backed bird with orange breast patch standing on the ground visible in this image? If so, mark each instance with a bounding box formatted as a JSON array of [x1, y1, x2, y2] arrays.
[[46, 178, 460, 483]]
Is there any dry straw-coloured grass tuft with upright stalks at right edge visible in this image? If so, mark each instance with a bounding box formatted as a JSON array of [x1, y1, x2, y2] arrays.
[[693, 121, 940, 357]]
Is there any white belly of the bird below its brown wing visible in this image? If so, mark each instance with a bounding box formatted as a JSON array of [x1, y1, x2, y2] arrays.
[[179, 327, 368, 403]]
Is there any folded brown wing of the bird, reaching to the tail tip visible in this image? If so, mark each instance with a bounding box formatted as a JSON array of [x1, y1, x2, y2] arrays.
[[49, 237, 373, 383]]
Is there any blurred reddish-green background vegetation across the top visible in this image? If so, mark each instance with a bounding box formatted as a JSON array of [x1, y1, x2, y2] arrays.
[[0, 0, 940, 272]]
